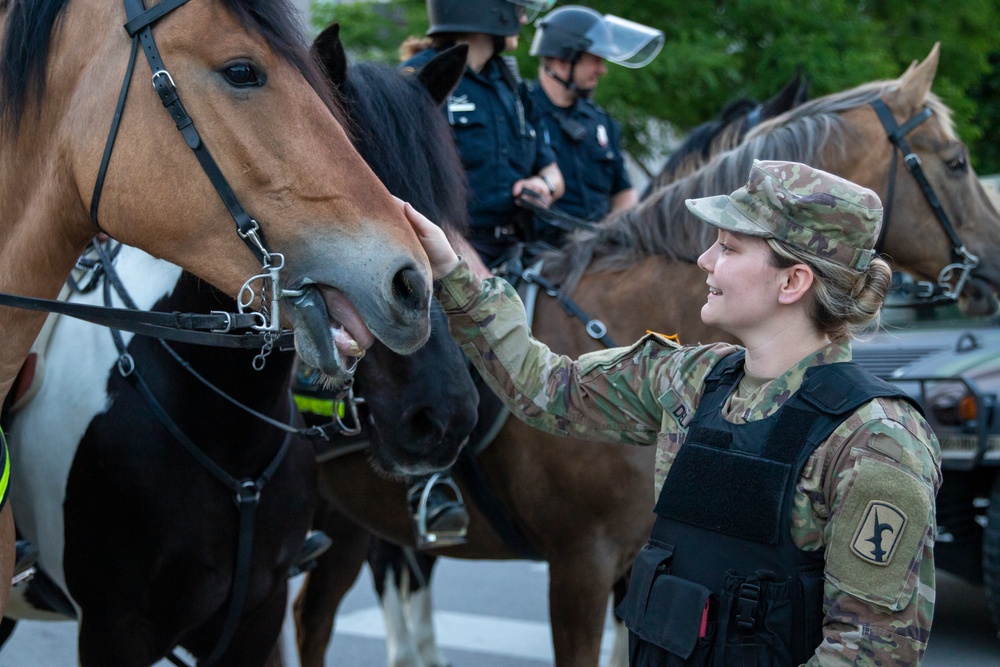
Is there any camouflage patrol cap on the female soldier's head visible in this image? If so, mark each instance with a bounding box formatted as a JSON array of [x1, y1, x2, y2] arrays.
[[684, 160, 882, 271]]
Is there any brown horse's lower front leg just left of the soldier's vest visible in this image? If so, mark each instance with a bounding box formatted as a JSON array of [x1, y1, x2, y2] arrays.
[[549, 545, 616, 667]]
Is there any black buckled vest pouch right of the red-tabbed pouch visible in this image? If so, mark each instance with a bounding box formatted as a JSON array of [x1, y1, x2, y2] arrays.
[[718, 572, 792, 667]]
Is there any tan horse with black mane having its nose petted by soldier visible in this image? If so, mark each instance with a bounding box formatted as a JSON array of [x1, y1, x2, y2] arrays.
[[0, 0, 429, 607]]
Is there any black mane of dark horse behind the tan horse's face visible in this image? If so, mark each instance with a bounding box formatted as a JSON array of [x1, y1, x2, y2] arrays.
[[343, 63, 468, 234]]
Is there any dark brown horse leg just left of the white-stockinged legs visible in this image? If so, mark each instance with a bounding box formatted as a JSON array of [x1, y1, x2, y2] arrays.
[[295, 504, 371, 667]]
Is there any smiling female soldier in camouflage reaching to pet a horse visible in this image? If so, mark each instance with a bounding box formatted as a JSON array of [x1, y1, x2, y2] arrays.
[[404, 162, 941, 667]]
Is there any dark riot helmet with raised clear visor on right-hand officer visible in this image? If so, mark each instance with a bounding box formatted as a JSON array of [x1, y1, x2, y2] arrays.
[[530, 5, 663, 69]]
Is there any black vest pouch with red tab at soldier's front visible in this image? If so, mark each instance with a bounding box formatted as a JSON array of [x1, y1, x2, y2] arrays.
[[615, 540, 715, 667]]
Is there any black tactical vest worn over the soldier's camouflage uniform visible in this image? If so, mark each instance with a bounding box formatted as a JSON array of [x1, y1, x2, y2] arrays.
[[616, 352, 910, 667]]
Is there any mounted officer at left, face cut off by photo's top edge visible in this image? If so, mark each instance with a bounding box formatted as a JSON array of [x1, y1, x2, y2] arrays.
[[403, 0, 564, 547]]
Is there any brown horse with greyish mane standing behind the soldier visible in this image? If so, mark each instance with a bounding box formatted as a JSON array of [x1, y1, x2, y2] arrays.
[[299, 47, 1000, 667]]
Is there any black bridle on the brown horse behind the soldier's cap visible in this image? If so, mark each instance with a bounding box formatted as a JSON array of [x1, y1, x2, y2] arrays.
[[871, 99, 979, 302]]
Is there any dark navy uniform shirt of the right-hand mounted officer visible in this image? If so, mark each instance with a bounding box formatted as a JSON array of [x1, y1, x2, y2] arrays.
[[528, 83, 632, 242]]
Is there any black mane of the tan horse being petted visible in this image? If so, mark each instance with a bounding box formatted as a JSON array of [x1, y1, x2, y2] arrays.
[[0, 0, 343, 129]]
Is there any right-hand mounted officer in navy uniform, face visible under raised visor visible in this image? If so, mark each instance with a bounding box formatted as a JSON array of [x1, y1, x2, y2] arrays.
[[529, 5, 663, 243]]
